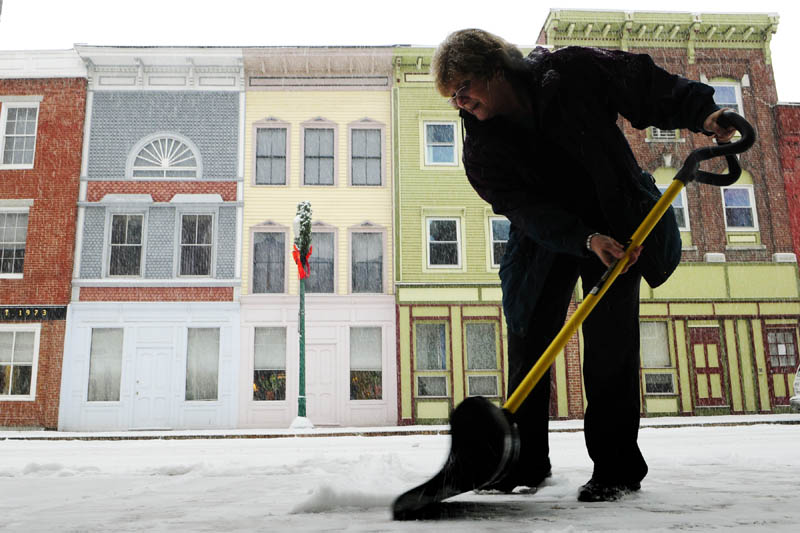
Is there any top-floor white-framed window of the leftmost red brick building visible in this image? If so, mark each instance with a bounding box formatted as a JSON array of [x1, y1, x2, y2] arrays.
[[0, 102, 39, 168]]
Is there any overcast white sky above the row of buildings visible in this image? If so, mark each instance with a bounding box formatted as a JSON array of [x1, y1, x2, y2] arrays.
[[0, 0, 800, 102]]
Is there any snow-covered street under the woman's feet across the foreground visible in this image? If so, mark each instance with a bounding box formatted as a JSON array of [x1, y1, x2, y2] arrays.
[[0, 415, 800, 533]]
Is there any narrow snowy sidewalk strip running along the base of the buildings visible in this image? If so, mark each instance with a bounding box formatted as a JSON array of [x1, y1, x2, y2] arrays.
[[0, 413, 800, 441]]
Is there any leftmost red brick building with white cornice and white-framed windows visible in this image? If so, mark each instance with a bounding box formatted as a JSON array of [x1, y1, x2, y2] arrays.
[[0, 50, 86, 429]]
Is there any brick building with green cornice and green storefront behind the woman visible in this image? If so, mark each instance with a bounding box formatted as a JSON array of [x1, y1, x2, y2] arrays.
[[538, 9, 800, 416]]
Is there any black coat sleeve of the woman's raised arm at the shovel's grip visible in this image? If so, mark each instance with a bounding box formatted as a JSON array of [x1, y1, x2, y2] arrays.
[[563, 48, 719, 133]]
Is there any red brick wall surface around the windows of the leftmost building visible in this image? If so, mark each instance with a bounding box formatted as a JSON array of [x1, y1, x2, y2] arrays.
[[0, 78, 86, 428]]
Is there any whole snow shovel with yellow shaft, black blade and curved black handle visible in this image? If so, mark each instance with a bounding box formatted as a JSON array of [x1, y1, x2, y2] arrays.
[[392, 111, 755, 520]]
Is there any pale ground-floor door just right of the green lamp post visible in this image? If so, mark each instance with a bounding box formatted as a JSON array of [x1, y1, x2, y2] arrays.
[[306, 344, 339, 426]]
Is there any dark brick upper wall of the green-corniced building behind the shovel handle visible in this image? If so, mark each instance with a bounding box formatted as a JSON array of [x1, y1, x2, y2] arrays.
[[621, 48, 792, 262]]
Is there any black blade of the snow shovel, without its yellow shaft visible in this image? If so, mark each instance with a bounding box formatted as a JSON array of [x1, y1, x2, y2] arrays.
[[392, 396, 519, 520]]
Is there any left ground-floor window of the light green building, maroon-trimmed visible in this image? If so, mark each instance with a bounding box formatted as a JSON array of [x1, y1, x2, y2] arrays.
[[414, 323, 448, 397]]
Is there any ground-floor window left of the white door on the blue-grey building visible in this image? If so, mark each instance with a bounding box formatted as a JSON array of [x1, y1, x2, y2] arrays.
[[87, 328, 122, 402]]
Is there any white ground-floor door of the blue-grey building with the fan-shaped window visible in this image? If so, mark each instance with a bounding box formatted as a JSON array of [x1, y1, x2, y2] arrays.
[[133, 348, 172, 429]]
